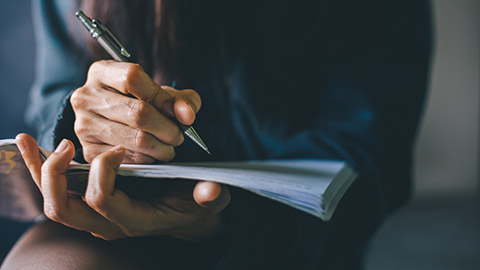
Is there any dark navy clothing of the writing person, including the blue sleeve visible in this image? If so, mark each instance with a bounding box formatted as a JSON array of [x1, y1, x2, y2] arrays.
[[28, 0, 430, 269]]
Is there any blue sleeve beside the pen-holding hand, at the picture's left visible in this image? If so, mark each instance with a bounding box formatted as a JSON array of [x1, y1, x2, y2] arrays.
[[25, 0, 88, 150]]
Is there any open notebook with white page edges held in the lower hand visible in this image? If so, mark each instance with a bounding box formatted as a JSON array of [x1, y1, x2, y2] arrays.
[[0, 140, 357, 221]]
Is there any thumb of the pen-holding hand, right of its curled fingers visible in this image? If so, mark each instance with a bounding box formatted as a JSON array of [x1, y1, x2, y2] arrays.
[[163, 86, 202, 125]]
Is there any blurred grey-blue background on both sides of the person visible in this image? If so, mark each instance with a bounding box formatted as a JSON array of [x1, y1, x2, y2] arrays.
[[0, 0, 480, 270]]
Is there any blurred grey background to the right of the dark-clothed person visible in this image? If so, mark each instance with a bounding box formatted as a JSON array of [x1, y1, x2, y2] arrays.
[[367, 0, 480, 270]]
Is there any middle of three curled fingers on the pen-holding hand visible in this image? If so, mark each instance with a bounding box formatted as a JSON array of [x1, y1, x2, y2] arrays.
[[71, 88, 183, 146]]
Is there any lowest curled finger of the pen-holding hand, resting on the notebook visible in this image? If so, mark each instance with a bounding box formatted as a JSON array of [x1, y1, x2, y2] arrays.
[[75, 113, 175, 163]]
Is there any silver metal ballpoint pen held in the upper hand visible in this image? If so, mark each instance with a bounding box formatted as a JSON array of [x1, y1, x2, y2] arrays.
[[75, 11, 211, 155]]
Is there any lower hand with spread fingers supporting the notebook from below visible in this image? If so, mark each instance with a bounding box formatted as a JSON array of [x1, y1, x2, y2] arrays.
[[16, 134, 230, 241]]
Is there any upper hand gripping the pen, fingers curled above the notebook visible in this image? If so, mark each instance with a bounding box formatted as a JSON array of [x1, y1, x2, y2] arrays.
[[70, 60, 201, 163]]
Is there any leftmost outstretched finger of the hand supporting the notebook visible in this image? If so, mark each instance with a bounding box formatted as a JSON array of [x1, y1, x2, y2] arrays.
[[15, 133, 42, 190]]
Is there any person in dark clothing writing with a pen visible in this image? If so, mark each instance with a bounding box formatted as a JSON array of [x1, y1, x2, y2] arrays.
[[2, 0, 430, 269]]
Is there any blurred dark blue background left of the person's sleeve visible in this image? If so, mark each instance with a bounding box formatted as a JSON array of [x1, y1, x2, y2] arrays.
[[0, 0, 36, 261]]
